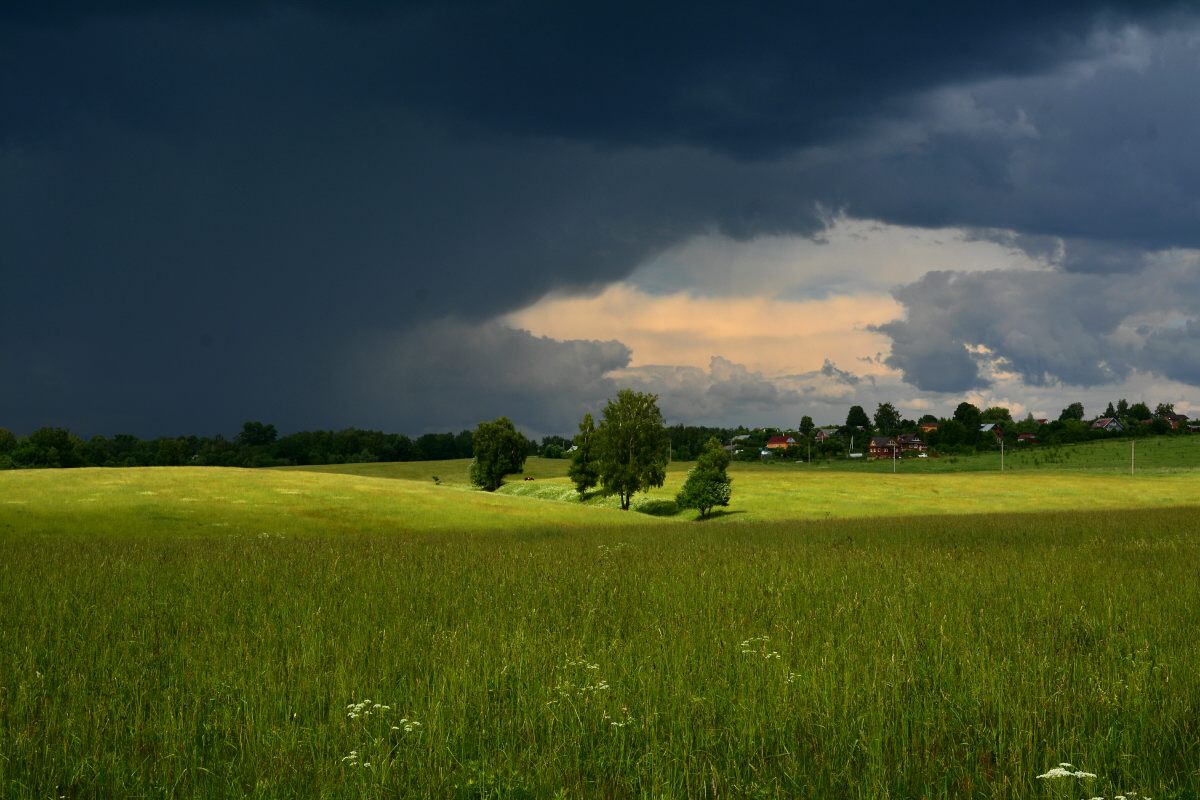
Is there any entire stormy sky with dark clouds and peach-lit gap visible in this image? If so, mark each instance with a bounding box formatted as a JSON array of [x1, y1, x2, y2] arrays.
[[7, 0, 1200, 437]]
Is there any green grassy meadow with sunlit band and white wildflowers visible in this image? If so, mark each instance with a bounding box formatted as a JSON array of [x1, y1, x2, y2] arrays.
[[0, 453, 1200, 799]]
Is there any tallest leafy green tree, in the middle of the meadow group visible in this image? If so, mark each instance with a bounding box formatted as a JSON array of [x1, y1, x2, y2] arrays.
[[595, 389, 671, 511]]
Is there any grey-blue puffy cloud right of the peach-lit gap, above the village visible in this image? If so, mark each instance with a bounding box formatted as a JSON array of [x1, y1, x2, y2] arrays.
[[878, 251, 1200, 392]]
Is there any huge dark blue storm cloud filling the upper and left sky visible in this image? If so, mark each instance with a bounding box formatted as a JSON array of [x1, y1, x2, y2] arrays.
[[7, 1, 1200, 433]]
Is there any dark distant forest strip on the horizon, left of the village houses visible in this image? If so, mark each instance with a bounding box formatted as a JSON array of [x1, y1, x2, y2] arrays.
[[0, 422, 734, 469]]
